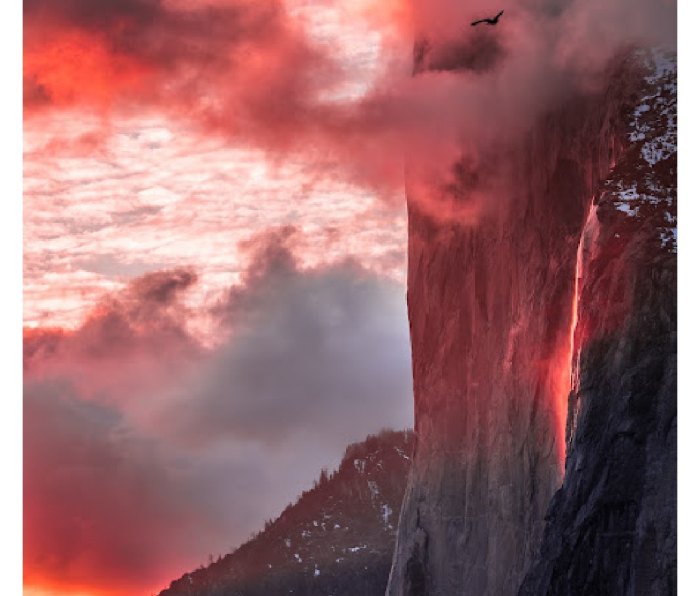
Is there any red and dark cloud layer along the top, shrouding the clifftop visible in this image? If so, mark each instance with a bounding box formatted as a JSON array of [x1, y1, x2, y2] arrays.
[[25, 0, 675, 205]]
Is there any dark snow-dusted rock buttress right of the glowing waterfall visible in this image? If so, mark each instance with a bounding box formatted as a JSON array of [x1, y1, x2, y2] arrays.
[[519, 50, 676, 596]]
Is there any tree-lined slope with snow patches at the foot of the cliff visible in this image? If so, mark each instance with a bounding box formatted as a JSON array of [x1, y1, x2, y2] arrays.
[[161, 431, 413, 596]]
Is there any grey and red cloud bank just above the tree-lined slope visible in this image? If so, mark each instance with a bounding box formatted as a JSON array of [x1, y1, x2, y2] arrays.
[[24, 228, 412, 593]]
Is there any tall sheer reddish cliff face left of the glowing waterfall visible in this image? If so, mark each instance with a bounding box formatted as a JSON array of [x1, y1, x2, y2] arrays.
[[387, 50, 670, 596]]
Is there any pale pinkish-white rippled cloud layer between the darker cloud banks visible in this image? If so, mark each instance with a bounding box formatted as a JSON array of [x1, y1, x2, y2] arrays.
[[24, 110, 406, 327]]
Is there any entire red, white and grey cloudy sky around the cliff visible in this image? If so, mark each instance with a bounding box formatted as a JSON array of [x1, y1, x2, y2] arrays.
[[23, 0, 675, 596]]
